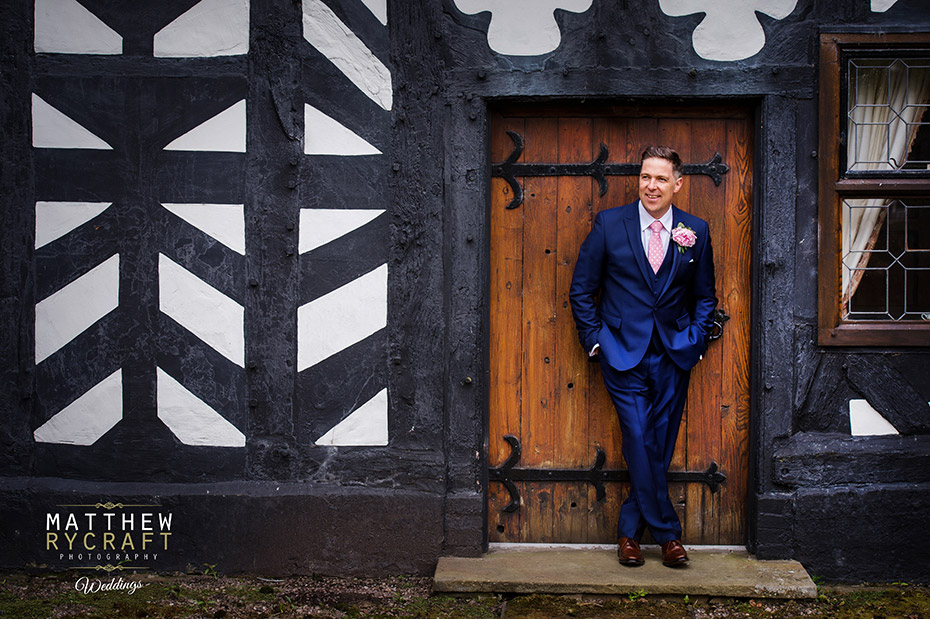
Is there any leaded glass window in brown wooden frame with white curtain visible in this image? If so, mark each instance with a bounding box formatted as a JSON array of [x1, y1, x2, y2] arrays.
[[818, 33, 930, 346]]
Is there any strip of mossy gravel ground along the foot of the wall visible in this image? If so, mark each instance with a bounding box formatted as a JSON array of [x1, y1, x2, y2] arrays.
[[0, 566, 930, 619]]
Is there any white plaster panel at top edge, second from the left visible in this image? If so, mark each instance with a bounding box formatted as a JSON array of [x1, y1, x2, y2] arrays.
[[154, 0, 249, 58]]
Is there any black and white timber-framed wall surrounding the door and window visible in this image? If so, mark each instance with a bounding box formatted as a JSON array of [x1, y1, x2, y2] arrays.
[[0, 0, 930, 581]]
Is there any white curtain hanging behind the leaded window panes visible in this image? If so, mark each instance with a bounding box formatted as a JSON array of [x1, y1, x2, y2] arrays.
[[841, 61, 930, 315]]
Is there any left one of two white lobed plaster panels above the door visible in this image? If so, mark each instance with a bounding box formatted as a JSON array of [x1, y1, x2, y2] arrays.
[[455, 0, 592, 56]]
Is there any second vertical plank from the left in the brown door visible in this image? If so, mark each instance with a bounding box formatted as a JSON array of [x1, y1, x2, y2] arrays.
[[520, 118, 559, 542]]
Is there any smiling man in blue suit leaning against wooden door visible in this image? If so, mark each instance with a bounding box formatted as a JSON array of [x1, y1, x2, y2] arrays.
[[569, 146, 717, 567]]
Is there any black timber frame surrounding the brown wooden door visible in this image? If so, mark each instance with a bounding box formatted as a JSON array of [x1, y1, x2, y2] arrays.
[[443, 93, 764, 552]]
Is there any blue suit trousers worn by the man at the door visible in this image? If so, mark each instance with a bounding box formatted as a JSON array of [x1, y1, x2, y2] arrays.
[[599, 337, 691, 544]]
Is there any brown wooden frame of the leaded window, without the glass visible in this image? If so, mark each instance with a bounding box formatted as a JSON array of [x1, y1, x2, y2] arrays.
[[817, 32, 930, 347]]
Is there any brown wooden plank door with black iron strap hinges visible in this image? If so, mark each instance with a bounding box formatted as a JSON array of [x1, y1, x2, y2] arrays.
[[488, 106, 752, 544]]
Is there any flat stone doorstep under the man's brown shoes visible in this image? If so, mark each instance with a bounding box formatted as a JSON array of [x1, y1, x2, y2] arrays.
[[433, 544, 817, 599]]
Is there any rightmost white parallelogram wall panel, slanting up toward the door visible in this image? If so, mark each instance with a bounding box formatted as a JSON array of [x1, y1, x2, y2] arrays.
[[297, 264, 388, 372]]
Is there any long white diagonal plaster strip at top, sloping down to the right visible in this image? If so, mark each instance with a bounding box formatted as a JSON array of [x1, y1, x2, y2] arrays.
[[303, 0, 394, 110]]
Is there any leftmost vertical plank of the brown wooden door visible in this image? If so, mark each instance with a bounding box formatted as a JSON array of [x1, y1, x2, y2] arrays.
[[488, 114, 524, 542]]
